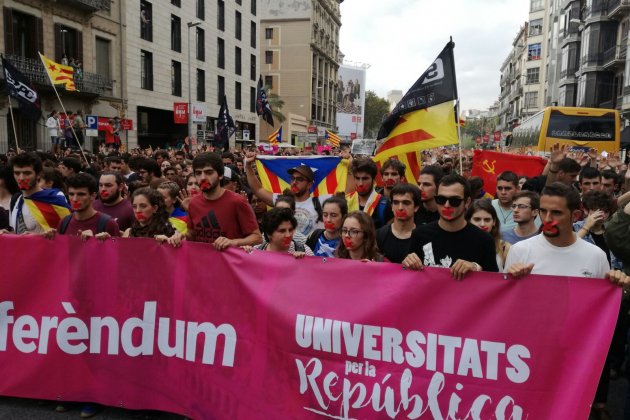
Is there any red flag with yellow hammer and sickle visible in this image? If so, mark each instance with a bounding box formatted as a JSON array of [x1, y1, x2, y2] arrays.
[[471, 150, 547, 195]]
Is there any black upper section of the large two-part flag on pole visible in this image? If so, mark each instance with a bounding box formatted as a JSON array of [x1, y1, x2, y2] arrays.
[[377, 41, 457, 139]]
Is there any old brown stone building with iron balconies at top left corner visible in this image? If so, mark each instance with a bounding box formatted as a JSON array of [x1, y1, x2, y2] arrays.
[[0, 0, 123, 153]]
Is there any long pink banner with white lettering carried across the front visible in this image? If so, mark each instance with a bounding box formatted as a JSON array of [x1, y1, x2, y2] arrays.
[[0, 235, 621, 419]]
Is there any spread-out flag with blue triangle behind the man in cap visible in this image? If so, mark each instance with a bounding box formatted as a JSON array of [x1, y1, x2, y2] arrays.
[[256, 156, 348, 196]]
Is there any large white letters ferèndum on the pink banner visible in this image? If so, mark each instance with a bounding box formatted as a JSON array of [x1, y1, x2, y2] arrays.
[[0, 301, 236, 367]]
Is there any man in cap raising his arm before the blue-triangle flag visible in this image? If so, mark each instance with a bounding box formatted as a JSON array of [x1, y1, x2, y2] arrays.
[[245, 152, 331, 237]]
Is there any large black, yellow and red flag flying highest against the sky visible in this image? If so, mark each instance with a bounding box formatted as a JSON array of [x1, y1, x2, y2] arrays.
[[374, 42, 459, 164]]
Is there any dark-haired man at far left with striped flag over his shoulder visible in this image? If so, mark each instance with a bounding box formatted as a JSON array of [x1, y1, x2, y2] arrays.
[[2, 153, 70, 234]]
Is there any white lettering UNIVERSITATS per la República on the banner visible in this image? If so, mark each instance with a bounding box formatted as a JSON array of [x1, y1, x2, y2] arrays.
[[295, 314, 531, 420]]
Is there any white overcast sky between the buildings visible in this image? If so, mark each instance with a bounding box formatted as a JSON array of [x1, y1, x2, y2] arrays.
[[339, 0, 530, 110]]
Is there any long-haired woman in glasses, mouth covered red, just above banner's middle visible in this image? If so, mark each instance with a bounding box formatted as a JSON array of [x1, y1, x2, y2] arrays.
[[336, 211, 385, 262]]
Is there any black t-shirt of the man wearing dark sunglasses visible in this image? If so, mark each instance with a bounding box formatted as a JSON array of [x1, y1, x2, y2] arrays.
[[410, 222, 499, 272]]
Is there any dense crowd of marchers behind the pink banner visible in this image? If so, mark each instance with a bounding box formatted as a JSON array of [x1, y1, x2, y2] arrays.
[[0, 143, 630, 419]]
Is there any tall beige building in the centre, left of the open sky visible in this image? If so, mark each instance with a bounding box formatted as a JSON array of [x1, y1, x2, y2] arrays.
[[260, 0, 343, 145]]
